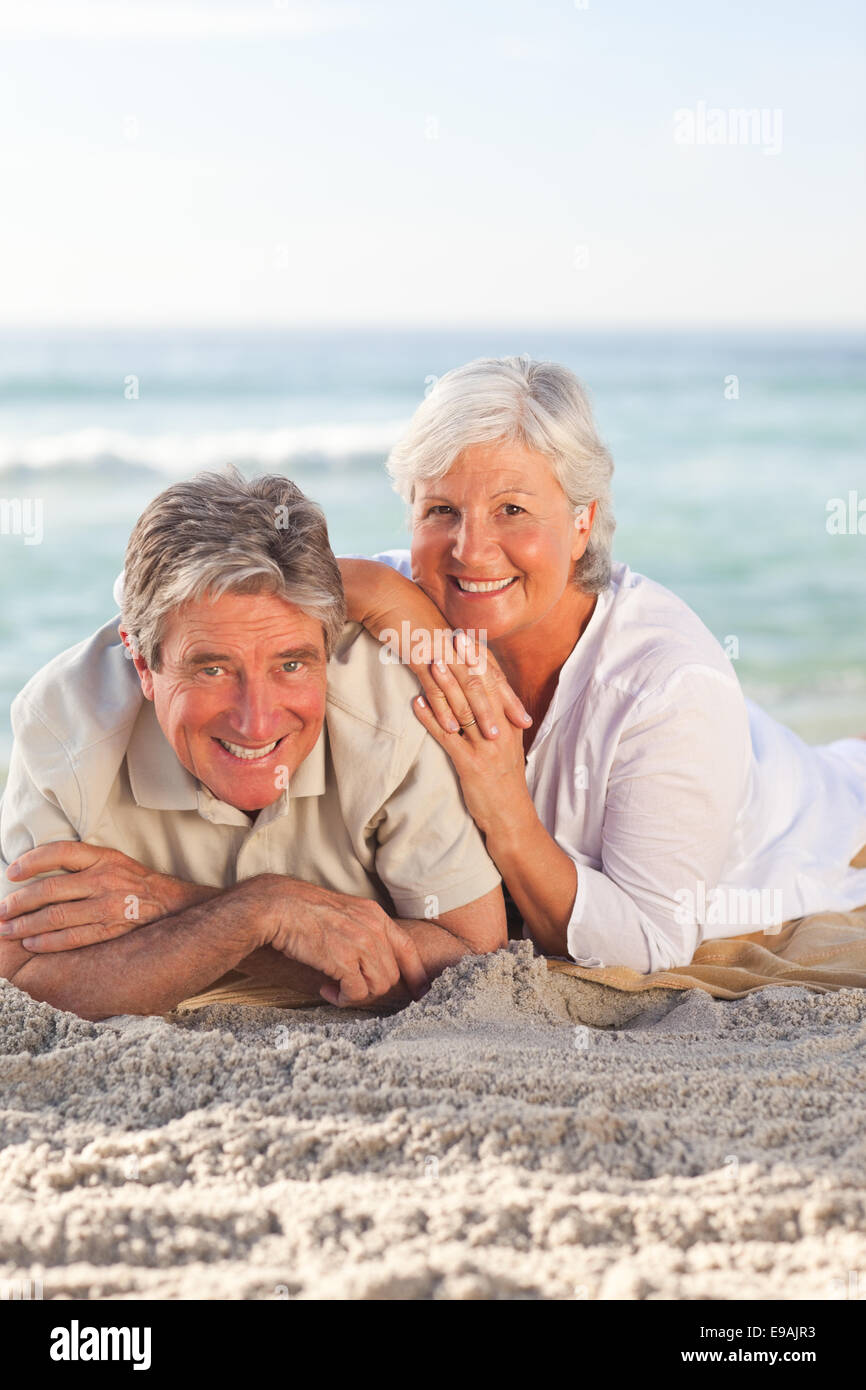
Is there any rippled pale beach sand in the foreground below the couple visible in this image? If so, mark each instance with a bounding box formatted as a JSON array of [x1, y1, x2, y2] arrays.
[[0, 942, 866, 1301]]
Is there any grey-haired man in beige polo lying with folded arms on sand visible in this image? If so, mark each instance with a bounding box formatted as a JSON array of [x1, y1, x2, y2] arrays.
[[0, 468, 506, 1019]]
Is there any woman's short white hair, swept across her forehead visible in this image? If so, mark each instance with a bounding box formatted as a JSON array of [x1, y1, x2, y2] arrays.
[[386, 357, 616, 594]]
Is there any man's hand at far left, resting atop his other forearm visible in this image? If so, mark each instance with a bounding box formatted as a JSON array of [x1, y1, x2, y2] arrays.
[[0, 840, 220, 952]]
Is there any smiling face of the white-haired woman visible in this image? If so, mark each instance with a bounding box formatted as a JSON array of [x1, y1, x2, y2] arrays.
[[411, 442, 595, 641]]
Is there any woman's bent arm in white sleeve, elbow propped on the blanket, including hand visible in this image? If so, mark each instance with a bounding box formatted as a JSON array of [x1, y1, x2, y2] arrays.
[[416, 647, 749, 973]]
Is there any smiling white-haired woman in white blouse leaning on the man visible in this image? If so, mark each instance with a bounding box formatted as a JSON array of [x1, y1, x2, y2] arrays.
[[341, 357, 866, 972]]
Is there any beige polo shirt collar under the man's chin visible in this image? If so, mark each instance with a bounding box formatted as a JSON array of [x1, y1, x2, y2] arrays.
[[126, 699, 328, 824]]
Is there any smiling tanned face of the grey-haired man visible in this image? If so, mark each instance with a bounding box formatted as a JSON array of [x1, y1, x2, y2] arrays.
[[127, 594, 327, 813]]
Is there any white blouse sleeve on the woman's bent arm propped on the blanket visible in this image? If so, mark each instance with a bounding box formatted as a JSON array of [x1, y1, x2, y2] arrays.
[[567, 666, 751, 973]]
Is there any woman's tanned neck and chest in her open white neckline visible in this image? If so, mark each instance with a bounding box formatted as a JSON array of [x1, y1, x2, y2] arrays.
[[491, 585, 598, 737]]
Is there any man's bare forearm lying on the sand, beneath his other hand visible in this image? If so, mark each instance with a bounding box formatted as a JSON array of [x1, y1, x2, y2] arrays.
[[11, 884, 261, 1020]]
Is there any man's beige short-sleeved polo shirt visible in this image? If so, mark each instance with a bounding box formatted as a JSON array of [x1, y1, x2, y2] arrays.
[[0, 614, 500, 917]]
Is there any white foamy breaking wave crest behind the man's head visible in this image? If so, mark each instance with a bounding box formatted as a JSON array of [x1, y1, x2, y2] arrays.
[[0, 420, 406, 475]]
